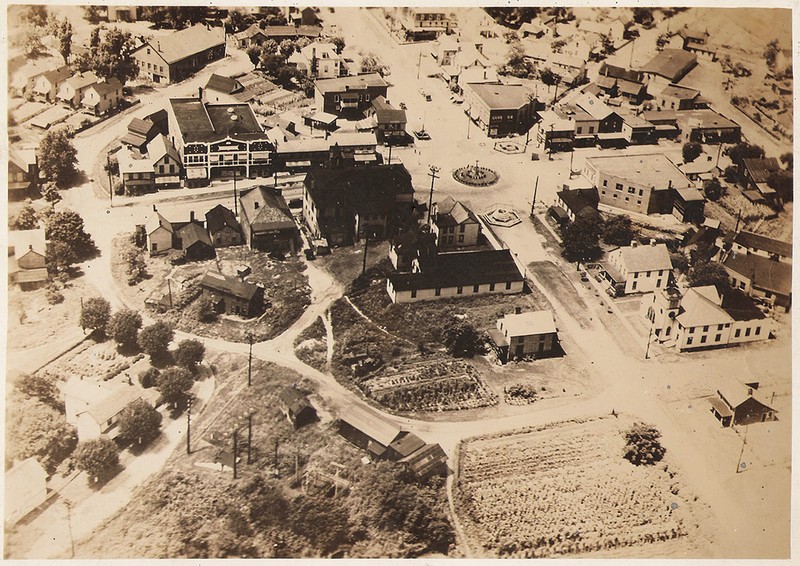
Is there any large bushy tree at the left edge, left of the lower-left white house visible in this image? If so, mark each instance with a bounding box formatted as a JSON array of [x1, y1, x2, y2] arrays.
[[6, 398, 78, 472]]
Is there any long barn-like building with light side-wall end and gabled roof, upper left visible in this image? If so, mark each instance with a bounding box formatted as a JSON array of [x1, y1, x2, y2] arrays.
[[133, 24, 225, 83]]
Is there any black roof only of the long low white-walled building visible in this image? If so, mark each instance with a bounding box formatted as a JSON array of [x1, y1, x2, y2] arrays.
[[389, 250, 523, 291]]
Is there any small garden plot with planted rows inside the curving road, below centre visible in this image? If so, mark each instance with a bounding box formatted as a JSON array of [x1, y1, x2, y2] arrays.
[[361, 359, 497, 411]]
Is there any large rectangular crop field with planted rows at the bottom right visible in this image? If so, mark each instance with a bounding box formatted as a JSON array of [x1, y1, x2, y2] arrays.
[[455, 417, 693, 558]]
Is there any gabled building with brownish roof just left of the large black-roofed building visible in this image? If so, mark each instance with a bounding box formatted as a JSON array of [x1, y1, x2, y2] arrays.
[[239, 186, 300, 254]]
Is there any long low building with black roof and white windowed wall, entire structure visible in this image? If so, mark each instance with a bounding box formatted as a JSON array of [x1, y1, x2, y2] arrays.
[[386, 250, 525, 303]]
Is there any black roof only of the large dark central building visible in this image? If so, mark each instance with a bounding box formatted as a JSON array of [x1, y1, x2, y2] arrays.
[[305, 164, 414, 219]]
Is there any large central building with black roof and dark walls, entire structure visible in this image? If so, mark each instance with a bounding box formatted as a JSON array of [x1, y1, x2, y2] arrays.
[[303, 164, 414, 246]]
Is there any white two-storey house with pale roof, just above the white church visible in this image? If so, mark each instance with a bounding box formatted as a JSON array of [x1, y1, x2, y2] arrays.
[[602, 240, 672, 294]]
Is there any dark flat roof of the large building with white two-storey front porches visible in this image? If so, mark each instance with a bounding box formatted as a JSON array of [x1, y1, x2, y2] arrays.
[[169, 98, 266, 143]]
